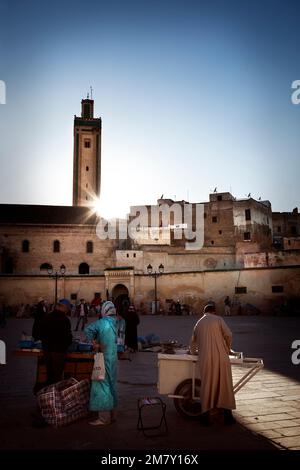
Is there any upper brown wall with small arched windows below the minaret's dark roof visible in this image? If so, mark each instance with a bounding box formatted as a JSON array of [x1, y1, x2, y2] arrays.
[[0, 225, 115, 275]]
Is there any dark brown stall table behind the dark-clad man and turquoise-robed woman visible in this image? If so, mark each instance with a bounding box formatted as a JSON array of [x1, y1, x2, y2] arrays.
[[14, 349, 94, 392]]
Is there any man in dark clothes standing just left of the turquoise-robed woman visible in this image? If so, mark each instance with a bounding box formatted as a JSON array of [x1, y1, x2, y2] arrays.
[[41, 299, 72, 385]]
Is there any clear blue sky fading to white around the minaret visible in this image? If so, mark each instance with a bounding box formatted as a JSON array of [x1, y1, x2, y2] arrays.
[[0, 0, 300, 217]]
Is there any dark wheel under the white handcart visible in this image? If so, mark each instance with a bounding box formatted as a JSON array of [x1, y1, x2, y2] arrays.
[[174, 379, 201, 419]]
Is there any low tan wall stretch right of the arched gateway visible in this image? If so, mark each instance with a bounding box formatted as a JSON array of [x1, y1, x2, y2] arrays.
[[135, 266, 300, 313]]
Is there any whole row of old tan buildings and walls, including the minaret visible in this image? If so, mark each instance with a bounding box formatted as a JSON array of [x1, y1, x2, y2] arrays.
[[0, 99, 300, 311]]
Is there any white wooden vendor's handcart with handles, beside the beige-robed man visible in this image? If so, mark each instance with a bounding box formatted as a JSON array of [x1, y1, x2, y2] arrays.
[[158, 353, 264, 419]]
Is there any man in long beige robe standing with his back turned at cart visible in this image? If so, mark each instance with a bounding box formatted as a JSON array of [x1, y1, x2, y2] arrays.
[[190, 303, 235, 425]]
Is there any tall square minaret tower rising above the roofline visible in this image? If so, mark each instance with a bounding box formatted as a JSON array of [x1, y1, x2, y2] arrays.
[[73, 93, 102, 206]]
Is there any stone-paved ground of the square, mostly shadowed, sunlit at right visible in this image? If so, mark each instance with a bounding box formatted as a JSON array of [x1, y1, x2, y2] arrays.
[[0, 316, 300, 451]]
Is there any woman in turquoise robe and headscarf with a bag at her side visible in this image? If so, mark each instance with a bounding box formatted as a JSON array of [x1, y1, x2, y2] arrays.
[[84, 301, 118, 426]]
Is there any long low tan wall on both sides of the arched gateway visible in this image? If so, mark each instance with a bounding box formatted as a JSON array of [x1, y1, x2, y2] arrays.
[[0, 266, 300, 313]]
